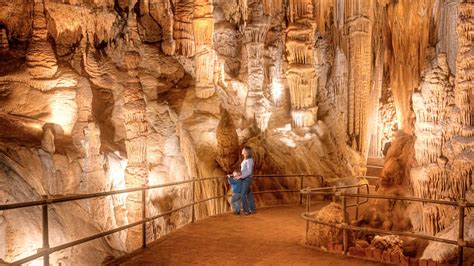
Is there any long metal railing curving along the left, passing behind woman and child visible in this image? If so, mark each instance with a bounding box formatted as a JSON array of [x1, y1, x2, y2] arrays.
[[0, 174, 324, 265]]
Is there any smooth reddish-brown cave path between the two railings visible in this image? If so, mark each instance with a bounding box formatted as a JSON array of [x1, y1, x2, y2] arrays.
[[115, 206, 382, 266]]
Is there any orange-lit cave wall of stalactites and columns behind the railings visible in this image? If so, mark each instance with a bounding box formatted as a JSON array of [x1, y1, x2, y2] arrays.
[[0, 0, 474, 265]]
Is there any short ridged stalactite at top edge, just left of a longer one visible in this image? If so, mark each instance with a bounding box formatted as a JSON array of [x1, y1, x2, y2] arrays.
[[174, 0, 195, 57]]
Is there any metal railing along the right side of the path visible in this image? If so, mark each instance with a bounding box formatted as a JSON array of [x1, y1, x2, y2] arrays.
[[301, 187, 474, 265]]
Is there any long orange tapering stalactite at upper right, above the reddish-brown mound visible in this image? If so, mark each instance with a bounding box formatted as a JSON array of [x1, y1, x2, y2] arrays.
[[387, 0, 434, 133]]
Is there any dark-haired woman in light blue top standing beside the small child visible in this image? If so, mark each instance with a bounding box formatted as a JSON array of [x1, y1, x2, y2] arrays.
[[240, 146, 257, 215]]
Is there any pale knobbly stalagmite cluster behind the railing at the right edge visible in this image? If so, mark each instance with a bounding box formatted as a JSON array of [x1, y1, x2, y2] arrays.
[[411, 51, 474, 234]]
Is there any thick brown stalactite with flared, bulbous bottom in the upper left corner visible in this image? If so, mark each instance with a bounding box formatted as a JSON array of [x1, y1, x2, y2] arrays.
[[26, 0, 58, 78]]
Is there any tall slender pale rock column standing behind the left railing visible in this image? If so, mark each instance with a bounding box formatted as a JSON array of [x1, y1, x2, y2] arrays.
[[123, 51, 148, 250]]
